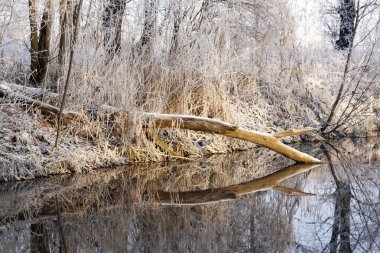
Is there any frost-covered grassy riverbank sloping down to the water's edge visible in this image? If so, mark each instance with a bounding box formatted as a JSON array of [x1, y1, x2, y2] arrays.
[[0, 78, 380, 181]]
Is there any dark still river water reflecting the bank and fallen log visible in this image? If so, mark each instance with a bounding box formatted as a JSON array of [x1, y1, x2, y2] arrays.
[[0, 140, 380, 252]]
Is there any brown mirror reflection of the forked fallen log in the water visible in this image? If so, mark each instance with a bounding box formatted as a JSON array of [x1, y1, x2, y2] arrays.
[[156, 164, 319, 205]]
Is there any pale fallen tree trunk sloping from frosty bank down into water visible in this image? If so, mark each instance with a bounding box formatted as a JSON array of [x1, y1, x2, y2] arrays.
[[0, 83, 321, 163]]
